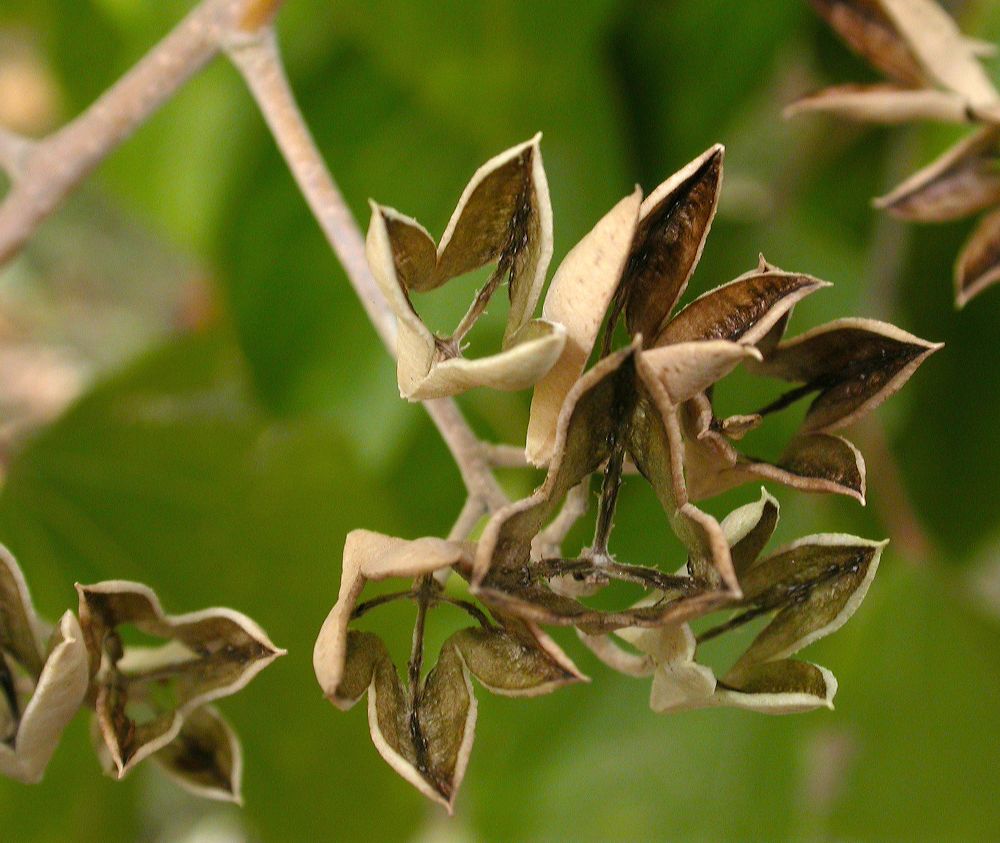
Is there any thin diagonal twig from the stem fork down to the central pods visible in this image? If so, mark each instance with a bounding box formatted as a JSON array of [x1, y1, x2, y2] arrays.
[[227, 28, 507, 512]]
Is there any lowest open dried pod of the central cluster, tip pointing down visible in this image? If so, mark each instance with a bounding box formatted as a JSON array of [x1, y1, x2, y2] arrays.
[[313, 530, 584, 813]]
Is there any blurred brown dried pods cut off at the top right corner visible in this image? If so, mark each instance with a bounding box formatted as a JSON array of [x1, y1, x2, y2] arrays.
[[786, 0, 1000, 307]]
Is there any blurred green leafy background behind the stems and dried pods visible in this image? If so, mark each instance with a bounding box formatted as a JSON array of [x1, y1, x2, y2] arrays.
[[0, 0, 1000, 842]]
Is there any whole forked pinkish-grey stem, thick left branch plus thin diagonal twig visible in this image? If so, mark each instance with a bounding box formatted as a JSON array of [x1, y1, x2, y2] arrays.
[[0, 0, 507, 528]]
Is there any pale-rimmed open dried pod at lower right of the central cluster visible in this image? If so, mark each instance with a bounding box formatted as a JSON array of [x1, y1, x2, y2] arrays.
[[584, 492, 885, 714]]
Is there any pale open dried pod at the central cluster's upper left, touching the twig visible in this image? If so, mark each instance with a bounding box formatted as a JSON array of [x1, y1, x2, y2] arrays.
[[367, 135, 565, 401]]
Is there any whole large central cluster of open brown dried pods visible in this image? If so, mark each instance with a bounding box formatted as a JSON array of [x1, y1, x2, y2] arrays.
[[314, 138, 938, 810]]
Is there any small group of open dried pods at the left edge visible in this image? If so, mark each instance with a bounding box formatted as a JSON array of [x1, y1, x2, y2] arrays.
[[0, 546, 284, 802]]
